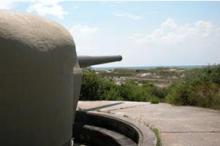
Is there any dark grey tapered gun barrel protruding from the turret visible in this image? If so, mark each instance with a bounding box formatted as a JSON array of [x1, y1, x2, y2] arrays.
[[78, 55, 122, 67]]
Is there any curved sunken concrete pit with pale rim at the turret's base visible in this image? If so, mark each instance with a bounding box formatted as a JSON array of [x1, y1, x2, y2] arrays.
[[73, 111, 157, 146]]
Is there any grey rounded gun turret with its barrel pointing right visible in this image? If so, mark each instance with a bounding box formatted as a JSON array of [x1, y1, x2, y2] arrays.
[[0, 11, 122, 146]]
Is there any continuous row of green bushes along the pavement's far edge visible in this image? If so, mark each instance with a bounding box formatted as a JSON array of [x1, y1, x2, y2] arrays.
[[80, 65, 220, 109]]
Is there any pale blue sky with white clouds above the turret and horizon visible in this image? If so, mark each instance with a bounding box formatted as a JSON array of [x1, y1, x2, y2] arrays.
[[0, 0, 220, 66]]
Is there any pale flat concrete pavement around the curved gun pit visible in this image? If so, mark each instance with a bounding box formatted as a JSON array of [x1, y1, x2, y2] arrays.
[[78, 101, 220, 146]]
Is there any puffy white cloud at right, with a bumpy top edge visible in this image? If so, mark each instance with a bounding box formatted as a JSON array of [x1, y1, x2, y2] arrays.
[[131, 18, 219, 45]]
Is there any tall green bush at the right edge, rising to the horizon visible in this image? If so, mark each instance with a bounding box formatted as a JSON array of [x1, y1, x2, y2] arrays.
[[166, 65, 220, 108]]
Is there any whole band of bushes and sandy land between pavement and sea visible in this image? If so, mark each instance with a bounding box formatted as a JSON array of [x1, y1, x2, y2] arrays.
[[80, 65, 220, 109]]
